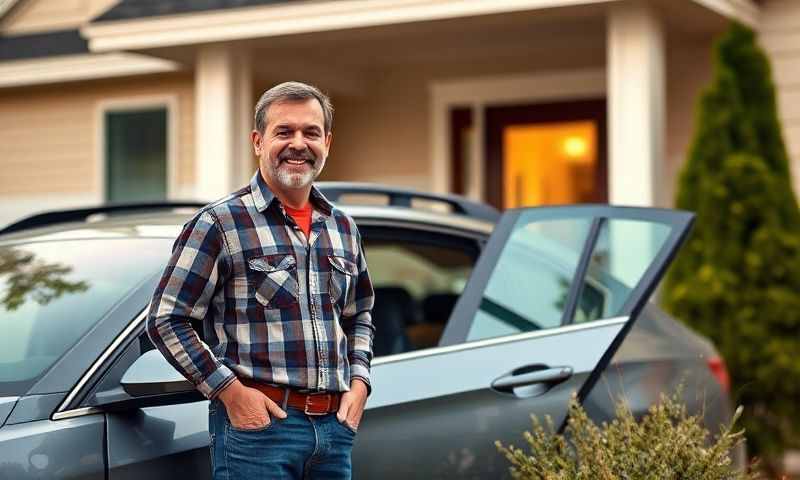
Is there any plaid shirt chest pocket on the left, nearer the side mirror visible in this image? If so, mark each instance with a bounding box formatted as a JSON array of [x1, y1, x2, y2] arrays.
[[247, 254, 298, 308]]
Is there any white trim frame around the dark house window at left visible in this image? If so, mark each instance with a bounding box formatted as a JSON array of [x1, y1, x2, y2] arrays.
[[94, 94, 184, 202]]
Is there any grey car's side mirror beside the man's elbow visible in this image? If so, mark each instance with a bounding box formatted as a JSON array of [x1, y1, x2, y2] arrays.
[[96, 350, 205, 412]]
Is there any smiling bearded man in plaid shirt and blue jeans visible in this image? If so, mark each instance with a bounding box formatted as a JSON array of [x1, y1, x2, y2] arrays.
[[147, 82, 374, 480]]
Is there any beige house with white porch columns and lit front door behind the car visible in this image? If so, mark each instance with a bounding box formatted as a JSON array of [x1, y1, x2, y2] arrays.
[[0, 0, 800, 227]]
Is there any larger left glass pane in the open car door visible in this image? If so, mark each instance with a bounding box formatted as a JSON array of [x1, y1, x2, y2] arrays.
[[468, 216, 593, 340]]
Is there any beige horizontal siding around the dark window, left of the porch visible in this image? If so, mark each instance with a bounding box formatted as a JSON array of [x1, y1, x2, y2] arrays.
[[0, 74, 194, 195]]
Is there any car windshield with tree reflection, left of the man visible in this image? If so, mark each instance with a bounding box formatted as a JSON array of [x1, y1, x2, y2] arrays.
[[0, 239, 170, 396]]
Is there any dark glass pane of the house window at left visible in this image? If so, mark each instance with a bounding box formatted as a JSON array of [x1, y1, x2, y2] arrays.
[[106, 108, 167, 202]]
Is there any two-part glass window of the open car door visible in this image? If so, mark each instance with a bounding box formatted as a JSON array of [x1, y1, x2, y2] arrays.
[[467, 213, 670, 340]]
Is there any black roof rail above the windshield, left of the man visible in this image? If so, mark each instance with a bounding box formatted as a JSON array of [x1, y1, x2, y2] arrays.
[[0, 201, 206, 235]]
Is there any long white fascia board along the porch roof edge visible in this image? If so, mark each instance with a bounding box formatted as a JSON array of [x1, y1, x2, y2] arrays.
[[81, 0, 619, 52]]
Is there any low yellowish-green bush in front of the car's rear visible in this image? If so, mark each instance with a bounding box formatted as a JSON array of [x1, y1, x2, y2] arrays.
[[496, 394, 758, 480]]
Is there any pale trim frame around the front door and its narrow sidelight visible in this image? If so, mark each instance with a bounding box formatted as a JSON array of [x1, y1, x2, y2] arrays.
[[429, 68, 606, 201]]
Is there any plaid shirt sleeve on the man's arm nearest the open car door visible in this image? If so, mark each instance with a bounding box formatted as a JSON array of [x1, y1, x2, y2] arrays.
[[340, 231, 375, 394]]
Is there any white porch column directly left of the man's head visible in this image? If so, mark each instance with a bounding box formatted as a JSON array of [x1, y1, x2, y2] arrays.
[[195, 45, 255, 201]]
